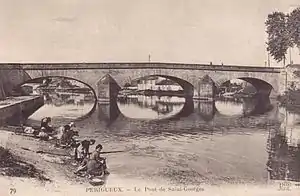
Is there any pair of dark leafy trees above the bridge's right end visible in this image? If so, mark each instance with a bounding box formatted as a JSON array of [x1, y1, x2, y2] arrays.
[[265, 7, 300, 64]]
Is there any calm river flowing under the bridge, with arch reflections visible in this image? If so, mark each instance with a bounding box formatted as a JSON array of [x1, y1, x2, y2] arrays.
[[28, 94, 300, 185]]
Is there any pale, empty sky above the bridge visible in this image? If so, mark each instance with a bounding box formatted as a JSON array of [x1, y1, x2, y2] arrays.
[[0, 0, 300, 66]]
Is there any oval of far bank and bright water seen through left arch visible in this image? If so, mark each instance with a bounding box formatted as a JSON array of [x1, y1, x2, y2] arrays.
[[22, 77, 96, 121]]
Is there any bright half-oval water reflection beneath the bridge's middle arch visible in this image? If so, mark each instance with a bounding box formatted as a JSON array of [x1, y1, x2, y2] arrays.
[[117, 95, 186, 119]]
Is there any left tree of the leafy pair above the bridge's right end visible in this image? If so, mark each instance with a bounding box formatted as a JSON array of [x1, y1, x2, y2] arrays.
[[265, 12, 292, 64]]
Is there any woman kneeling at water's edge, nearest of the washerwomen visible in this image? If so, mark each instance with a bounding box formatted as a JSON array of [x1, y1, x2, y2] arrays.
[[74, 144, 109, 177]]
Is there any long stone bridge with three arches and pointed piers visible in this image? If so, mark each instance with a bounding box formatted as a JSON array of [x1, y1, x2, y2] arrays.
[[2, 63, 285, 98]]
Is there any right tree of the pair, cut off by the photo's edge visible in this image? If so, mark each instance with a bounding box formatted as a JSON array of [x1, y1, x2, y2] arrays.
[[287, 7, 300, 49]]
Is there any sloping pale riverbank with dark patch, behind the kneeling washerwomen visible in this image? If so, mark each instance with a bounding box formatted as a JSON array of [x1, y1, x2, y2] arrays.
[[0, 129, 96, 195]]
